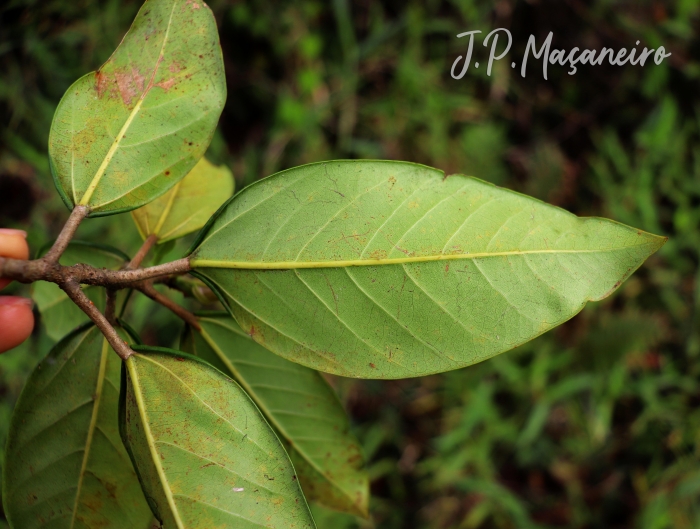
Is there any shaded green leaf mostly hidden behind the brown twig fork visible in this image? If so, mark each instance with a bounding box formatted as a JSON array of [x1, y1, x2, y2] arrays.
[[32, 241, 129, 341]]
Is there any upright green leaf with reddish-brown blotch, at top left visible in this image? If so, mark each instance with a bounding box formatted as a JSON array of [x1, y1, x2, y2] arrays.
[[49, 0, 226, 216]]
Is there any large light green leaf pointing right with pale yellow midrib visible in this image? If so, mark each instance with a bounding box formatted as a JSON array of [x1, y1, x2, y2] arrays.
[[190, 161, 666, 378]]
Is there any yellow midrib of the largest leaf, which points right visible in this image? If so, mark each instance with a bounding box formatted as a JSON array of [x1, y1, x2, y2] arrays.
[[190, 241, 656, 270]]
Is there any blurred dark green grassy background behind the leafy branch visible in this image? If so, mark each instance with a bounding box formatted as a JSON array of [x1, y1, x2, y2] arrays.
[[0, 0, 700, 529]]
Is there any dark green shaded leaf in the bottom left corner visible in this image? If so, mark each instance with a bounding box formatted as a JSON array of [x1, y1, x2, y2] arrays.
[[2, 324, 153, 529]]
